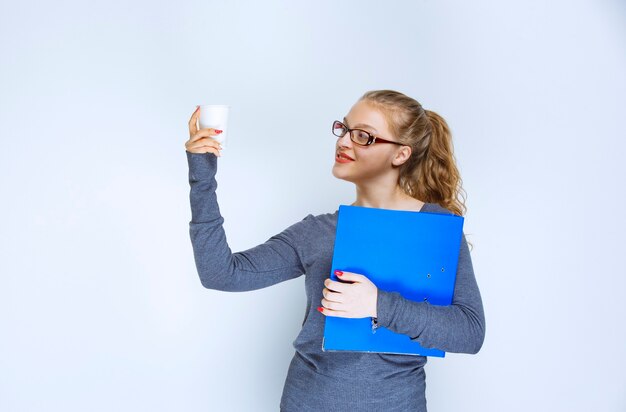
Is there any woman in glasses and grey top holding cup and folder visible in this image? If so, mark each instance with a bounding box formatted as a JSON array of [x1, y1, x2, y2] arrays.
[[185, 90, 485, 412]]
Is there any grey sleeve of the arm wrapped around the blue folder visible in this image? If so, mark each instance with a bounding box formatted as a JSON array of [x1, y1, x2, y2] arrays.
[[376, 234, 485, 354]]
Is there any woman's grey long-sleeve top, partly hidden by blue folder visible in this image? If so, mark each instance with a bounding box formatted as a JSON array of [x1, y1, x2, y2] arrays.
[[186, 152, 485, 412]]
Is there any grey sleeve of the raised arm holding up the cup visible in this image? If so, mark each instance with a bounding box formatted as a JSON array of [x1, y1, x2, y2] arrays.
[[186, 151, 314, 292]]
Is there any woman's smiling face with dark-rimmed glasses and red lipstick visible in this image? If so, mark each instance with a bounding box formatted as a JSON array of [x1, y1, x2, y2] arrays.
[[333, 100, 403, 183]]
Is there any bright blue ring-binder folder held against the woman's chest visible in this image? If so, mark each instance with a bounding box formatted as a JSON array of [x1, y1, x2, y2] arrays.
[[322, 205, 464, 357]]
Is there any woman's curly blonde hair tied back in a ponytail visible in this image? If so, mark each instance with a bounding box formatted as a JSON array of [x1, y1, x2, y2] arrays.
[[359, 90, 467, 216]]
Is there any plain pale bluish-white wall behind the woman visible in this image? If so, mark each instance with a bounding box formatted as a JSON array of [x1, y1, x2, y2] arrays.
[[0, 0, 626, 412]]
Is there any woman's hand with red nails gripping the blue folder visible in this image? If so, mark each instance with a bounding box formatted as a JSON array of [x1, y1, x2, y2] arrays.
[[318, 270, 378, 318]]
